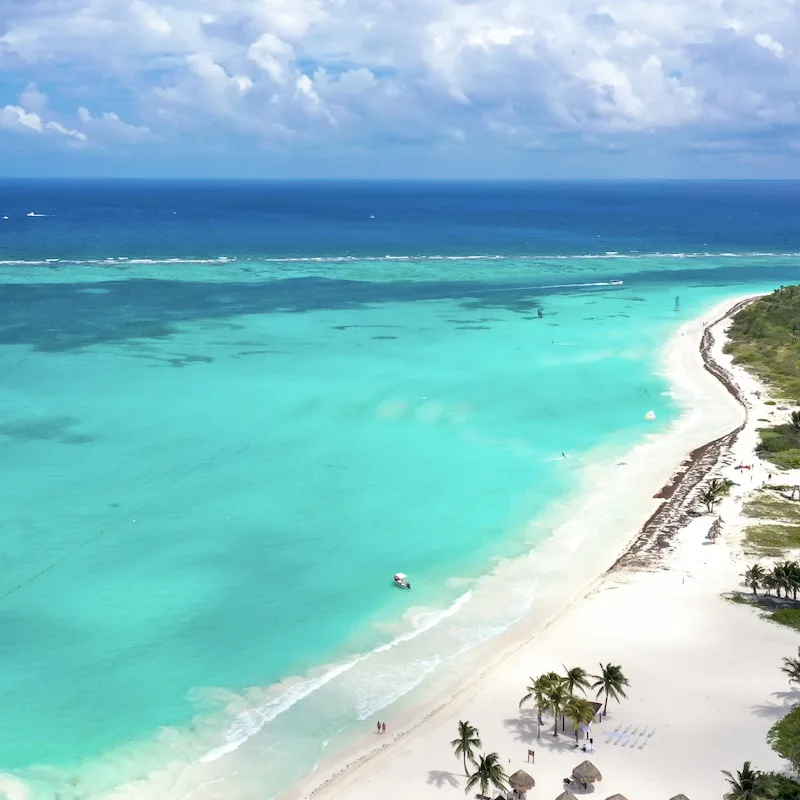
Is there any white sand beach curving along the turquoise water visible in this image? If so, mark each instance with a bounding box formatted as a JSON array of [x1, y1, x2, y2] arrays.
[[286, 298, 798, 800]]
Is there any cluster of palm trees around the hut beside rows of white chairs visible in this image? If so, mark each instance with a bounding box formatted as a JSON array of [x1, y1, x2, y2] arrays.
[[519, 663, 630, 743]]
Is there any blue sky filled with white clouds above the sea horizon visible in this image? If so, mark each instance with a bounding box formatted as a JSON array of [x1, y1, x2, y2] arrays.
[[0, 0, 800, 178]]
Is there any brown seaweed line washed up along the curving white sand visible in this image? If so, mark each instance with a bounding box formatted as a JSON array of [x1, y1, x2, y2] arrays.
[[609, 298, 753, 572]]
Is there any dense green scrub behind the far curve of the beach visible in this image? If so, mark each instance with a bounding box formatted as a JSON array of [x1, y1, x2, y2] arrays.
[[725, 286, 800, 469]]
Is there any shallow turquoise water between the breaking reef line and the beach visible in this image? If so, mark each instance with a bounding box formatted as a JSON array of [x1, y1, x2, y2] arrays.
[[0, 248, 800, 798]]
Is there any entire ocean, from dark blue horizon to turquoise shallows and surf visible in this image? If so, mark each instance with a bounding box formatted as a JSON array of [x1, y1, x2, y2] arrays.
[[0, 181, 800, 800]]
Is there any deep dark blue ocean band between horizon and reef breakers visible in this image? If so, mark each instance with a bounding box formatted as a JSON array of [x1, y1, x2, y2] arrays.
[[0, 181, 800, 260]]
